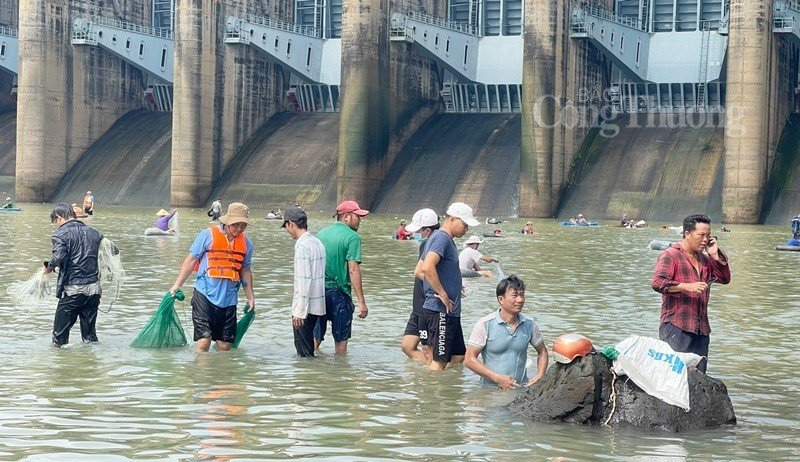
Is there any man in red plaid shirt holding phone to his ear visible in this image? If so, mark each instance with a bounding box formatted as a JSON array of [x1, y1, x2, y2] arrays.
[[652, 214, 731, 372]]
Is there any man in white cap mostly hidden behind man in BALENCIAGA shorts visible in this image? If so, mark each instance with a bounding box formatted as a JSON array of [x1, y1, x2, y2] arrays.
[[400, 209, 439, 364]]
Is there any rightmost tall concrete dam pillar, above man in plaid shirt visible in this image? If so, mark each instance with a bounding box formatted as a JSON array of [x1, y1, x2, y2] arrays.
[[722, 0, 773, 223]]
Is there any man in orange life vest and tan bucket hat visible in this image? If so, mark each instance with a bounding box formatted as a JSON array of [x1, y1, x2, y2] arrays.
[[170, 202, 255, 352]]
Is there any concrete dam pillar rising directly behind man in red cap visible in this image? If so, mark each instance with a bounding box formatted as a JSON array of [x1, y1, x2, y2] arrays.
[[337, 0, 390, 207]]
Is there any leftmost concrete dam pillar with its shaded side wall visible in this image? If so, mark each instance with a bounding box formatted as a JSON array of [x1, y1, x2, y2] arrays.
[[15, 0, 146, 203]]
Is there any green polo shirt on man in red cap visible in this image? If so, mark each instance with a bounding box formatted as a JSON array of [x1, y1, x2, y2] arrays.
[[317, 221, 361, 297]]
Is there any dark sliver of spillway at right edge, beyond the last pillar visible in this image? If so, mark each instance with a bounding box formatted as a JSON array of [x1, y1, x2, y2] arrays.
[[761, 114, 800, 225]]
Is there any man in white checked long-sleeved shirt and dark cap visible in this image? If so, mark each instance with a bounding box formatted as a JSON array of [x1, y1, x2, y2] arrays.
[[282, 207, 325, 357]]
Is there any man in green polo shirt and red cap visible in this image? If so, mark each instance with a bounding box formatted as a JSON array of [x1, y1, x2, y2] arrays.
[[314, 201, 369, 354]]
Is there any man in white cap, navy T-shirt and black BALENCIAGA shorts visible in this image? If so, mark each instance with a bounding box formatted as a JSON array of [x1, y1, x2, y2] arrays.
[[414, 202, 480, 371]]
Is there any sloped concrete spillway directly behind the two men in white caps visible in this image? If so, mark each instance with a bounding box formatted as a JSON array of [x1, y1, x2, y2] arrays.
[[372, 114, 520, 216]]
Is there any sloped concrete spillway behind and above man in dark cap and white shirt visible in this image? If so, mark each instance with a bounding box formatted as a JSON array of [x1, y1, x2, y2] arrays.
[[208, 112, 339, 210]]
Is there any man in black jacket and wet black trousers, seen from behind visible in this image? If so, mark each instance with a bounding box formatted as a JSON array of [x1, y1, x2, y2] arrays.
[[44, 202, 103, 347]]
